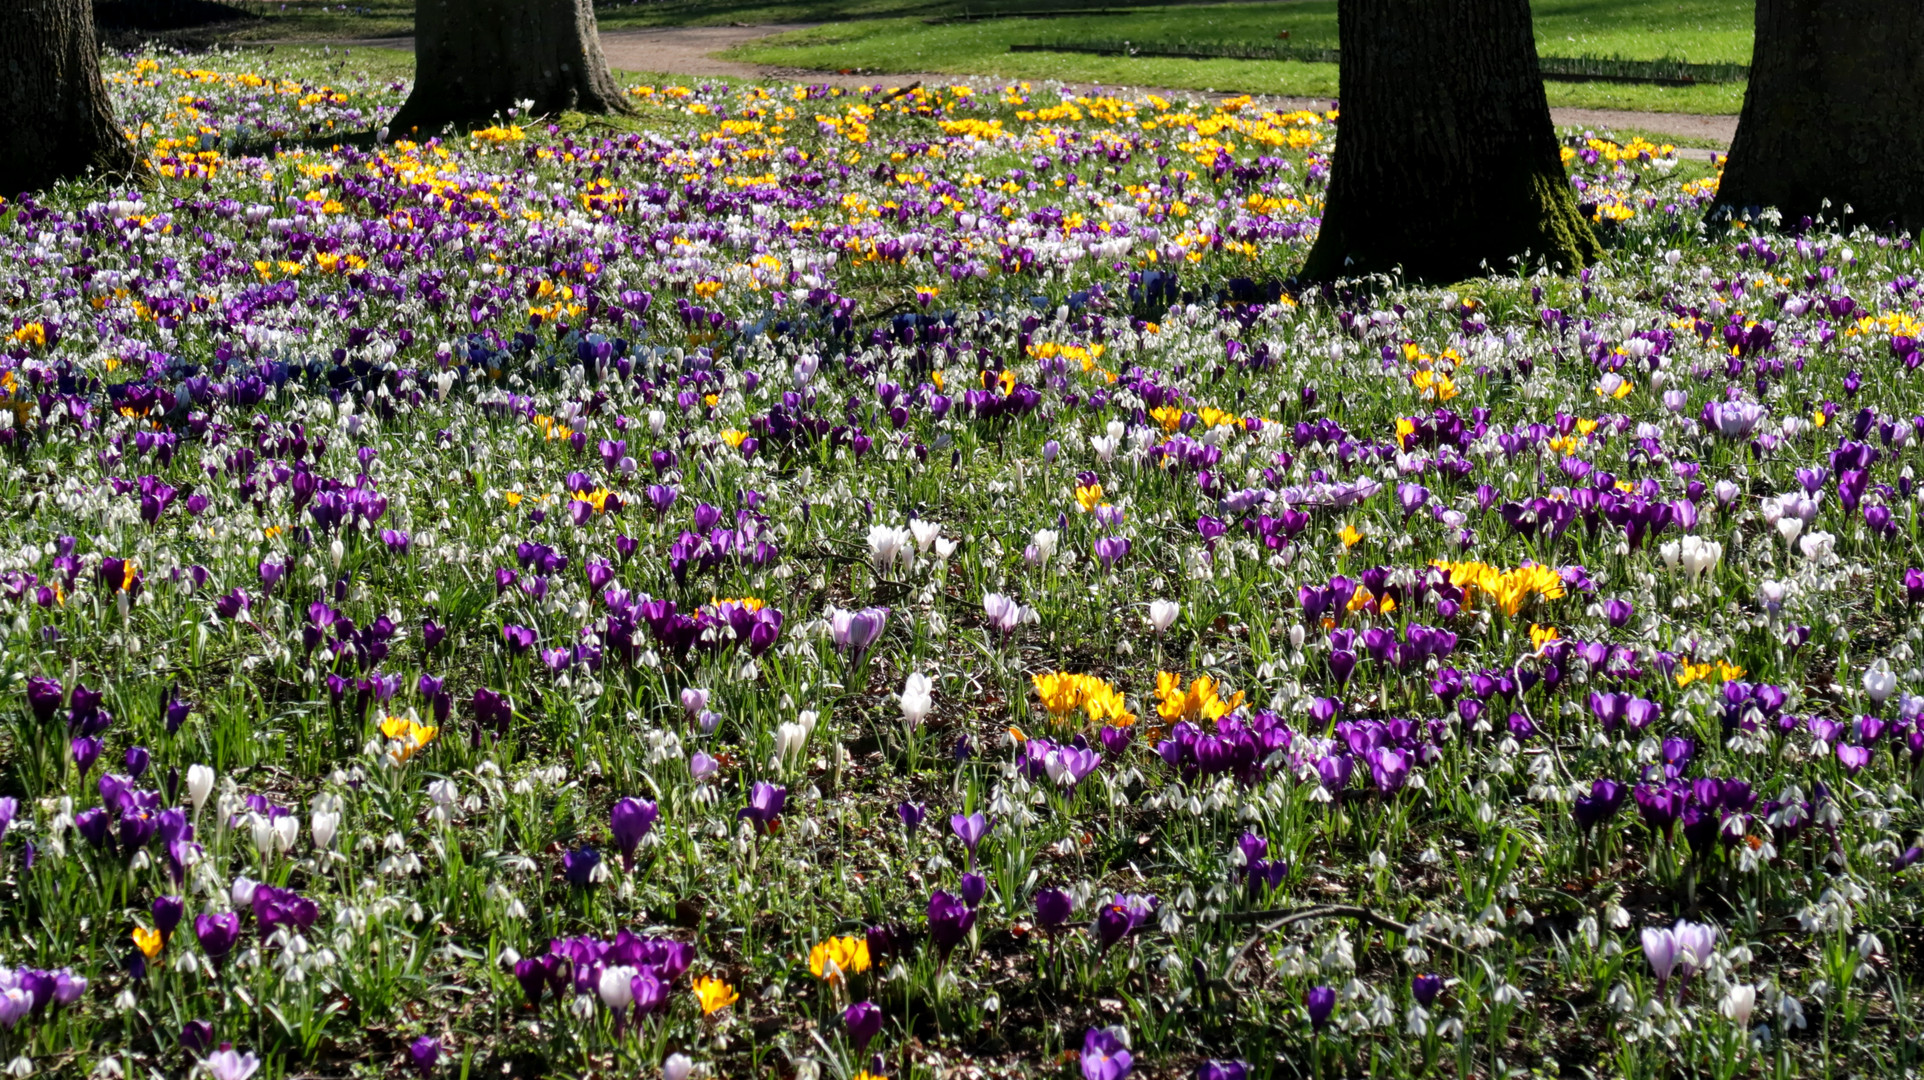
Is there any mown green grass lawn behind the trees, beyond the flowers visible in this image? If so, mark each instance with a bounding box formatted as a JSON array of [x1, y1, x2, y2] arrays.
[[210, 0, 1751, 114]]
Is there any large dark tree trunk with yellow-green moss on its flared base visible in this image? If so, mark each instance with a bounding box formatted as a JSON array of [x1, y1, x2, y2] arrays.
[[1303, 0, 1601, 281]]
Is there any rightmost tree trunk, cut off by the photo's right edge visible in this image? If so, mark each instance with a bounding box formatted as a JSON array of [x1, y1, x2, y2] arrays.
[[1716, 0, 1924, 231]]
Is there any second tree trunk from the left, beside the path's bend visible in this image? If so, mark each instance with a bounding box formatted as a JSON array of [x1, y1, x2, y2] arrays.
[[389, 0, 629, 137]]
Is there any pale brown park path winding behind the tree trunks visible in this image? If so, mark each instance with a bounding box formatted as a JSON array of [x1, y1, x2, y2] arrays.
[[292, 23, 1737, 160]]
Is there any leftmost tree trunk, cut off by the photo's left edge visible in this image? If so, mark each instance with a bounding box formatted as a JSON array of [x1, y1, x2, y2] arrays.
[[0, 0, 139, 196]]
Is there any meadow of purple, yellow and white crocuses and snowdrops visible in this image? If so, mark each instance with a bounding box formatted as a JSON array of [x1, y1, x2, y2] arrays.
[[0, 46, 1924, 1080]]
